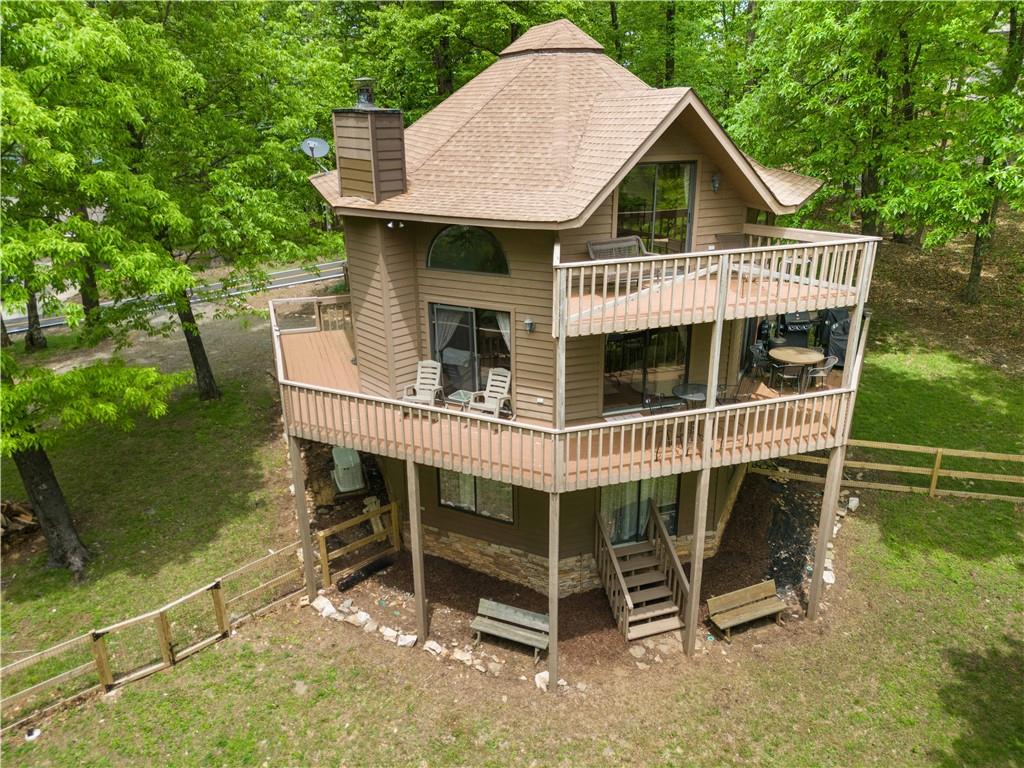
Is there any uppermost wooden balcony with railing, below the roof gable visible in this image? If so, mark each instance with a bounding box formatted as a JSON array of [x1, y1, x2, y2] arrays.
[[553, 224, 879, 337]]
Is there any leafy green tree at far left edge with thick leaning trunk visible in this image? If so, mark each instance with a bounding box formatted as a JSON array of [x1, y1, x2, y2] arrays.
[[0, 3, 191, 575]]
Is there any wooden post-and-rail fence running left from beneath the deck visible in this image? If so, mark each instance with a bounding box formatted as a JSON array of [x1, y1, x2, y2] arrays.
[[0, 504, 400, 732]]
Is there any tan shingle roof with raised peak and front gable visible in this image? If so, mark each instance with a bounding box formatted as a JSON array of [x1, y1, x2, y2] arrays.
[[310, 19, 817, 227]]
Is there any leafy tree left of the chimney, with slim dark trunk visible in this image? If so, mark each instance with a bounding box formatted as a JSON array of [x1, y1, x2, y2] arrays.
[[89, 2, 349, 399]]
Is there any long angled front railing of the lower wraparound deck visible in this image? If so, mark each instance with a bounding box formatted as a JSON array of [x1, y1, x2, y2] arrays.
[[281, 380, 852, 493]]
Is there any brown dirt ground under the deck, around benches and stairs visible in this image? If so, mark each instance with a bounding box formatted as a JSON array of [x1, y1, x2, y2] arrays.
[[303, 475, 820, 679]]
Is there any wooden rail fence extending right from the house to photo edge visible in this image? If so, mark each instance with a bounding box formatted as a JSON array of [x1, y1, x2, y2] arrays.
[[751, 440, 1024, 503]]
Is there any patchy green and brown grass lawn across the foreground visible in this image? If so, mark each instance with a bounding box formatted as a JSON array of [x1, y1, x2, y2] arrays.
[[3, 494, 1024, 766]]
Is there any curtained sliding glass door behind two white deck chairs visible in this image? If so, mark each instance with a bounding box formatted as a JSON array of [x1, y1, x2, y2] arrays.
[[430, 304, 512, 394]]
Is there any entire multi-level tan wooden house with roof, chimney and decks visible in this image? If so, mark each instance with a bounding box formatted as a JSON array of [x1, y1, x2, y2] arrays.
[[271, 20, 877, 679]]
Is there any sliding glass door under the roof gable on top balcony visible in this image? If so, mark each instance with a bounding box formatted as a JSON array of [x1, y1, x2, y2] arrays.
[[616, 163, 696, 253]]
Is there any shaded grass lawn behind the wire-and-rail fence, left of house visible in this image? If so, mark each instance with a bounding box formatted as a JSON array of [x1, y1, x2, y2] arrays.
[[0, 380, 294, 660]]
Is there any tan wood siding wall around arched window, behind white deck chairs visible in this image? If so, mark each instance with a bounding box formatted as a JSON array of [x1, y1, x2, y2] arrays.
[[407, 224, 555, 424]]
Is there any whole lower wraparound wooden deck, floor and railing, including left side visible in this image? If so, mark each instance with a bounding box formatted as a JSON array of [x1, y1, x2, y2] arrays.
[[270, 290, 864, 493]]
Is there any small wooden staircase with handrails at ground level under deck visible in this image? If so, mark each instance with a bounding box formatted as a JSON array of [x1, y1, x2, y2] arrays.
[[594, 509, 689, 640]]
